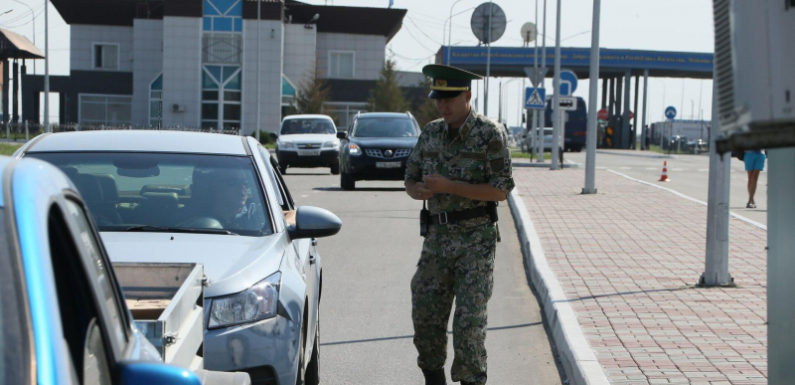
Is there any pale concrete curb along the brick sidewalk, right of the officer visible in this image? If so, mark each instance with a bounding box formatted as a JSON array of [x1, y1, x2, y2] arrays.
[[508, 187, 610, 385]]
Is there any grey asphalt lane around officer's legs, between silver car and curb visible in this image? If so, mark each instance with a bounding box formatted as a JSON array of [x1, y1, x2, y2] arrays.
[[285, 168, 561, 385]]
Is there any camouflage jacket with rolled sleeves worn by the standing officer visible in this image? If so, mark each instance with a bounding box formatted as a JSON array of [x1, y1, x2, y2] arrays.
[[405, 108, 514, 224]]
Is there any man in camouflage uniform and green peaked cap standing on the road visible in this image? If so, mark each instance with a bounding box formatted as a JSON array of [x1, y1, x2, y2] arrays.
[[405, 64, 514, 385]]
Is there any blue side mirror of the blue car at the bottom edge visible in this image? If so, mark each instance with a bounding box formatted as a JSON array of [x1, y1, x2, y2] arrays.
[[119, 362, 201, 385]]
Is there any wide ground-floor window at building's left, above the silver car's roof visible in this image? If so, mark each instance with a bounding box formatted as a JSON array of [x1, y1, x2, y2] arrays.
[[79, 94, 132, 126]]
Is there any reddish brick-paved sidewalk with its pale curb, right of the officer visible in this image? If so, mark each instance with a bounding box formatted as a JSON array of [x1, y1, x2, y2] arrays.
[[510, 162, 767, 385]]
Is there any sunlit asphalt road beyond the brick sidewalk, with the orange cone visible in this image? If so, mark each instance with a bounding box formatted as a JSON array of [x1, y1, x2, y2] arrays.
[[564, 150, 768, 225]]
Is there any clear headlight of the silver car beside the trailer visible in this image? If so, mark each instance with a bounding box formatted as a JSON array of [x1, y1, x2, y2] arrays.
[[207, 272, 282, 328]]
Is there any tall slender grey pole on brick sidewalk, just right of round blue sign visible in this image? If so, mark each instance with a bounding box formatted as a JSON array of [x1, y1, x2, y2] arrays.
[[582, 0, 601, 194]]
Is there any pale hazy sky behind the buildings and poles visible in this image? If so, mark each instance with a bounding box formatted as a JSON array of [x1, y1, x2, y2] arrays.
[[0, 0, 714, 126]]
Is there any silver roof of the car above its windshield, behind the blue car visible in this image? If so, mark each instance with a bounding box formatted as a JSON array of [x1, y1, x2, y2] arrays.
[[25, 130, 246, 155]]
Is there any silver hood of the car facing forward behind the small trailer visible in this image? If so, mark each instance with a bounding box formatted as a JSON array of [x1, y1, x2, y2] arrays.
[[100, 232, 284, 297]]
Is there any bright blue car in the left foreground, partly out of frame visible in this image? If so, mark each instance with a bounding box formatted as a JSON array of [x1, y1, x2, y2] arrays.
[[0, 157, 201, 385]]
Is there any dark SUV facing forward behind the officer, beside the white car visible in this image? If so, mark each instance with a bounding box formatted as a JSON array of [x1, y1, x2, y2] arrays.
[[337, 112, 420, 190]]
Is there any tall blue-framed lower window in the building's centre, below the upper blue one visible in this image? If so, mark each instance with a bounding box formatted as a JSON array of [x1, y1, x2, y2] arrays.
[[201, 65, 241, 131]]
